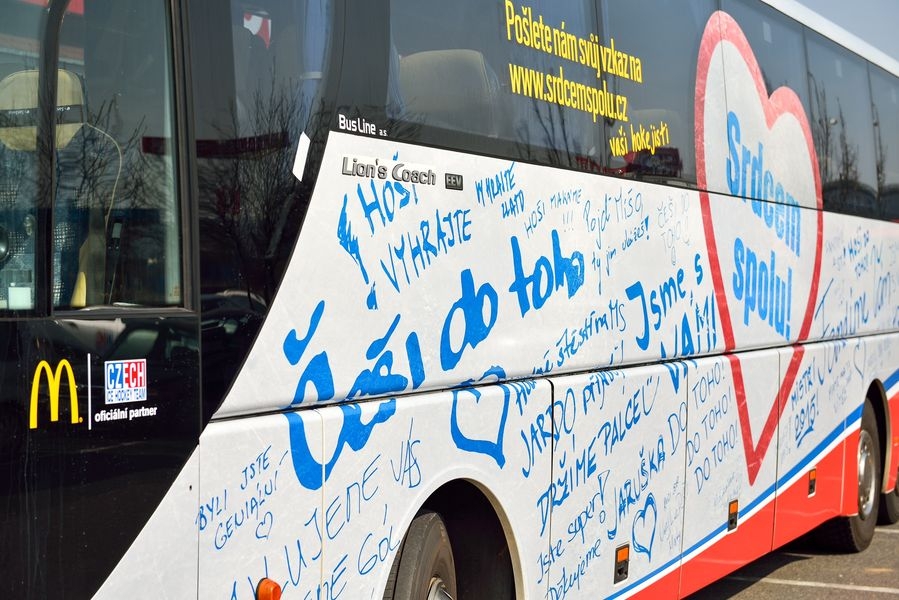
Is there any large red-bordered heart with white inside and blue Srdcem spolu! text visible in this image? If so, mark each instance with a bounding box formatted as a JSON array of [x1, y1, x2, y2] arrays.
[[694, 11, 823, 485]]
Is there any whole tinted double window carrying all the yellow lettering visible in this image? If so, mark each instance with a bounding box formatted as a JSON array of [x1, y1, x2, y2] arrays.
[[388, 0, 714, 183]]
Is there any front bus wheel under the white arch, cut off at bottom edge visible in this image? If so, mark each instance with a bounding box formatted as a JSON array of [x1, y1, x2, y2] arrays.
[[384, 510, 456, 600]]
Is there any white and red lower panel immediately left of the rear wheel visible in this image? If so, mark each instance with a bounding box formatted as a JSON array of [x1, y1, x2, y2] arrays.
[[774, 341, 860, 547]]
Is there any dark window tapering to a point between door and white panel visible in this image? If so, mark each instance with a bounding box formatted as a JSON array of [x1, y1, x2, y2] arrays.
[[190, 0, 331, 418]]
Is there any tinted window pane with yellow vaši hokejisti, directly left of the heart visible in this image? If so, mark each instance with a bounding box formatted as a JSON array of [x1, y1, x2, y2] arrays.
[[602, 0, 716, 183]]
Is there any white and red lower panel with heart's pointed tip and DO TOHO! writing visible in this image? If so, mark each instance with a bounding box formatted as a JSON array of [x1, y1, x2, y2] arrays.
[[681, 351, 780, 595]]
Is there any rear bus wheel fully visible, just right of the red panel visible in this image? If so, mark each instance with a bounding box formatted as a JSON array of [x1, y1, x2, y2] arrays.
[[820, 400, 882, 552]]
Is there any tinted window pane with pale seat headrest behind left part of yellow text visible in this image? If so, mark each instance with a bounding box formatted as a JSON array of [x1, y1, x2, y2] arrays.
[[388, 0, 603, 168]]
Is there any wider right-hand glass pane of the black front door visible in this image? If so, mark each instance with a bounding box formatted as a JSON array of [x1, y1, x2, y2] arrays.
[[52, 0, 181, 308]]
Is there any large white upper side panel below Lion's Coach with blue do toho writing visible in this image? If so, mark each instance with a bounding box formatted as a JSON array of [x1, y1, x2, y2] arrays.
[[209, 131, 723, 416]]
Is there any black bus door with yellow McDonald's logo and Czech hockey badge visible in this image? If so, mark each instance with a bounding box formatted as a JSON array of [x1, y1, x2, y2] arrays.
[[0, 0, 200, 598]]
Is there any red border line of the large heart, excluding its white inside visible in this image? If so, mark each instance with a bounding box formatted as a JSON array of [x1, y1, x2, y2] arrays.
[[695, 11, 824, 485]]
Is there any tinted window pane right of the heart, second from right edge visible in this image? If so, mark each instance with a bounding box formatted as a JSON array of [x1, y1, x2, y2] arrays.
[[806, 32, 877, 216]]
